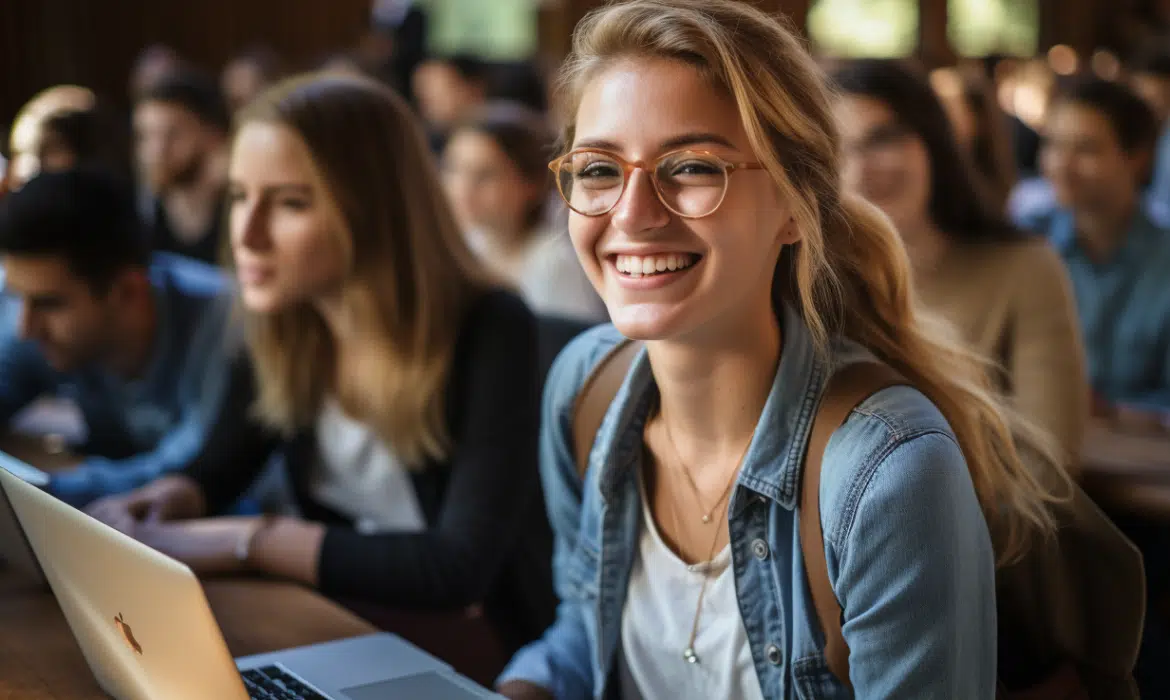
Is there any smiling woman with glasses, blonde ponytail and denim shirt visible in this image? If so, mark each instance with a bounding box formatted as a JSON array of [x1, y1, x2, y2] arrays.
[[498, 0, 1060, 700]]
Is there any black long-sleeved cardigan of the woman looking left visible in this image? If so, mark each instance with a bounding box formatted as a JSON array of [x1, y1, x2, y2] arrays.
[[185, 291, 556, 646]]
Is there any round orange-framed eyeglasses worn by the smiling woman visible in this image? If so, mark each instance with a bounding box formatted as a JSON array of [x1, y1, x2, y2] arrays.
[[549, 149, 764, 219]]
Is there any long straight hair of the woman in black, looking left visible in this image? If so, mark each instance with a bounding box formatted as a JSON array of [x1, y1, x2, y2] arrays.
[[238, 74, 489, 467]]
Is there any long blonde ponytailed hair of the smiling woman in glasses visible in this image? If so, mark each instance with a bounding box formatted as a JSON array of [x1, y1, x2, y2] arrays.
[[557, 0, 1068, 563]]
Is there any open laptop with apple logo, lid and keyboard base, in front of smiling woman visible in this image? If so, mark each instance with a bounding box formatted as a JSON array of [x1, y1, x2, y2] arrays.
[[0, 461, 498, 700]]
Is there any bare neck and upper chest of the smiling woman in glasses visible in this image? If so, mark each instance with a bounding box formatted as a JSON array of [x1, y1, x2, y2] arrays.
[[647, 313, 780, 472]]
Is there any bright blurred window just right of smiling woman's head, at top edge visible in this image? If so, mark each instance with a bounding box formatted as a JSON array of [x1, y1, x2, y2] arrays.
[[808, 0, 917, 59]]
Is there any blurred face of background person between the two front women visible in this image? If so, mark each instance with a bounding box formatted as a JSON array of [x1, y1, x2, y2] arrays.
[[442, 130, 539, 233]]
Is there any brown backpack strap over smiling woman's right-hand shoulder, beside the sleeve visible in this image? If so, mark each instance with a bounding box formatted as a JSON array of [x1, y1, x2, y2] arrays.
[[799, 362, 907, 689]]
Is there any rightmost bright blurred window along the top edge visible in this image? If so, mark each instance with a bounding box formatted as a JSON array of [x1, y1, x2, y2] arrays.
[[947, 0, 1040, 56]]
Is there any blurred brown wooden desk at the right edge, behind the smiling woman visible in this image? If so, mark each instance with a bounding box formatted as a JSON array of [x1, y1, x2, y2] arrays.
[[1081, 423, 1170, 520]]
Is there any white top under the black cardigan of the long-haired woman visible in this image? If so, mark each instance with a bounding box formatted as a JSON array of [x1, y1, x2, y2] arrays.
[[309, 398, 426, 534]]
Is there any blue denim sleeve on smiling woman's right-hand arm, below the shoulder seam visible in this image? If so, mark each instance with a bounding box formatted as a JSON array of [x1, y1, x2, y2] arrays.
[[834, 432, 996, 700]]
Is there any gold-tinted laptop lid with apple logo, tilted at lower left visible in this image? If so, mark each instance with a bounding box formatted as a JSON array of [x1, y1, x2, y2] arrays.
[[0, 469, 248, 700]]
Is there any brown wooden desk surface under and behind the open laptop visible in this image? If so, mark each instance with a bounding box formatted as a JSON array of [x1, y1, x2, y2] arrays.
[[0, 571, 377, 700]]
